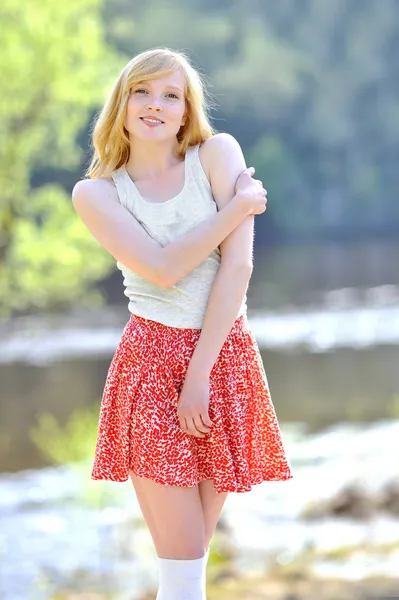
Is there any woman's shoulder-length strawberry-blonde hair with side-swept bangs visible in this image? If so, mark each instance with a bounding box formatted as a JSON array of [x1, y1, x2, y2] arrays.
[[85, 48, 216, 179]]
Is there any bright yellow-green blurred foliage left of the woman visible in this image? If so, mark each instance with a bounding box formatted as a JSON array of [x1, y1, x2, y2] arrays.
[[0, 0, 119, 313]]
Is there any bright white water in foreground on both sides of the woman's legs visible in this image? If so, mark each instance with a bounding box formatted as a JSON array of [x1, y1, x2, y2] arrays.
[[0, 420, 399, 600]]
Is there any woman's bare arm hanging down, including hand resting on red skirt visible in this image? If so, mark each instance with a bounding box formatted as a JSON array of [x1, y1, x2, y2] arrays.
[[177, 134, 266, 437]]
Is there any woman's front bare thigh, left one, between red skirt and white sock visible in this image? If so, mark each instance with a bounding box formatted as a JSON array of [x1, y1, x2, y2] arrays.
[[130, 472, 206, 559]]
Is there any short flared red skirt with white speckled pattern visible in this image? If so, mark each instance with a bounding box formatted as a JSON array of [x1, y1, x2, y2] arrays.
[[91, 314, 292, 493]]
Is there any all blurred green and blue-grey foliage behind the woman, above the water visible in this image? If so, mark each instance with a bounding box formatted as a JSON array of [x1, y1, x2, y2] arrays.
[[0, 0, 399, 312]]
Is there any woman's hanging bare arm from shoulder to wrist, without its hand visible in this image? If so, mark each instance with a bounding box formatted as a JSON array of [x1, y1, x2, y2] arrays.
[[187, 133, 254, 378]]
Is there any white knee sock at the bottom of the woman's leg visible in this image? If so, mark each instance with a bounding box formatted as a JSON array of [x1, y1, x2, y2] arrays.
[[156, 548, 209, 600]]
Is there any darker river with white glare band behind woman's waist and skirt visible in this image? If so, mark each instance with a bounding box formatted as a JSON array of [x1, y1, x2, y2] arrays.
[[0, 242, 399, 472]]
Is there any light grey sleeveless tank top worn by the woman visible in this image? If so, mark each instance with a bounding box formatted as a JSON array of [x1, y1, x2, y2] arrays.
[[111, 144, 247, 329]]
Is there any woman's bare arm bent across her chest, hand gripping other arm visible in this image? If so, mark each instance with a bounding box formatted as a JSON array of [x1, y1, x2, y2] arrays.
[[72, 169, 265, 287]]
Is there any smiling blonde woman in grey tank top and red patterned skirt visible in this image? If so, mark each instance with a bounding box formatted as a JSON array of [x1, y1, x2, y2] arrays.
[[72, 49, 292, 600]]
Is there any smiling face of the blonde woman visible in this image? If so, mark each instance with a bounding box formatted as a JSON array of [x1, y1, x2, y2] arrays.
[[125, 71, 186, 141]]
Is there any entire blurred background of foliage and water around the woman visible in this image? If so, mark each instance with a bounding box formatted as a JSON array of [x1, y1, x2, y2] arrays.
[[0, 0, 399, 600]]
